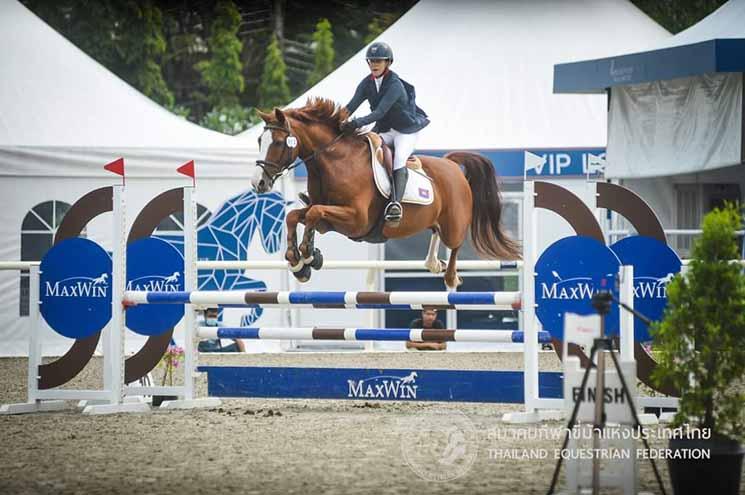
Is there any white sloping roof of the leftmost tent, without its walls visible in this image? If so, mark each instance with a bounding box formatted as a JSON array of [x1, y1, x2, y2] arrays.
[[0, 0, 256, 176]]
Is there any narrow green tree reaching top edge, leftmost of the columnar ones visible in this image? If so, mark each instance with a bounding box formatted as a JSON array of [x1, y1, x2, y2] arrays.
[[195, 0, 245, 107]]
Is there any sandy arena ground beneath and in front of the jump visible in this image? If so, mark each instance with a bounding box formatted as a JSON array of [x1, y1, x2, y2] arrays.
[[0, 352, 745, 495]]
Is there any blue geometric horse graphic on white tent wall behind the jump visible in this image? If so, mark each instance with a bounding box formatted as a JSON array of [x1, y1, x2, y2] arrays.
[[159, 191, 287, 326]]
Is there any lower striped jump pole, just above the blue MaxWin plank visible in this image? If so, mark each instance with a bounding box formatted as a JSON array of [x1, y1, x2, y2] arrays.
[[199, 327, 551, 343]]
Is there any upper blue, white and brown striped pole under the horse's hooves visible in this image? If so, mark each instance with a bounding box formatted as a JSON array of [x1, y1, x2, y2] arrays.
[[124, 291, 520, 310]]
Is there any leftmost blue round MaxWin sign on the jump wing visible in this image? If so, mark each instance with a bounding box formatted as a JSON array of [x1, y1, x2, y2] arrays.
[[39, 237, 111, 339]]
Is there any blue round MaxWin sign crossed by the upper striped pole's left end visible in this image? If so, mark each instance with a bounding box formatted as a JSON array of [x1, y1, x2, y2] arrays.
[[126, 237, 184, 335]]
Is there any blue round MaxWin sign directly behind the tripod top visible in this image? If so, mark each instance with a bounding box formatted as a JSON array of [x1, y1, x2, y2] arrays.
[[535, 236, 620, 340]]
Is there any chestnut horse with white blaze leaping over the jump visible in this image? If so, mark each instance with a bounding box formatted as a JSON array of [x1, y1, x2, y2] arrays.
[[252, 98, 520, 288]]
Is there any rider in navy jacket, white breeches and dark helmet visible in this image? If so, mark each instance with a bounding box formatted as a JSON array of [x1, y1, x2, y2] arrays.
[[340, 42, 429, 224]]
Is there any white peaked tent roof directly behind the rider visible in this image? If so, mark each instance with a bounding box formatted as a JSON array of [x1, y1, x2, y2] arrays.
[[244, 0, 670, 150]]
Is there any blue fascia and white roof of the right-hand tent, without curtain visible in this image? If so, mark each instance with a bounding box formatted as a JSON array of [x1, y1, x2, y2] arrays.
[[554, 0, 745, 93]]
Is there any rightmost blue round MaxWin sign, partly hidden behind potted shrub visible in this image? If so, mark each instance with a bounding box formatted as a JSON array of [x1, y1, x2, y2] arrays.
[[610, 236, 682, 342]]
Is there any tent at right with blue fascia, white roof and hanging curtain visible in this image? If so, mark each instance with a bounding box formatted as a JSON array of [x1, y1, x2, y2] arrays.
[[555, 0, 745, 178]]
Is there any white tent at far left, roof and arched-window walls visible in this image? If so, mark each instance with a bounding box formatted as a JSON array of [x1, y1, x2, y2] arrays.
[[0, 0, 263, 354]]
